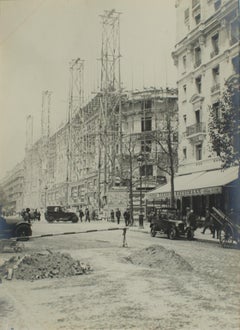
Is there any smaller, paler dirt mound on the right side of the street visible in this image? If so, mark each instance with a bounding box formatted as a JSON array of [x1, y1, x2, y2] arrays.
[[125, 245, 193, 271]]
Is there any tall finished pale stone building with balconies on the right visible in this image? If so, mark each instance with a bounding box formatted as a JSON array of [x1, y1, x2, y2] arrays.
[[147, 0, 240, 215]]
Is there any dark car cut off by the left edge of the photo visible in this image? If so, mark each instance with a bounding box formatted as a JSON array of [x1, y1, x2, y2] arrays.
[[0, 216, 32, 240]]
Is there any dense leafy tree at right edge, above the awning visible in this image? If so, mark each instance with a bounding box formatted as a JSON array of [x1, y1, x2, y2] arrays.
[[208, 78, 240, 178]]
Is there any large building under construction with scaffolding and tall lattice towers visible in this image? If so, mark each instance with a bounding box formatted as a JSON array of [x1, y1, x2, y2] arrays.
[[2, 10, 177, 217]]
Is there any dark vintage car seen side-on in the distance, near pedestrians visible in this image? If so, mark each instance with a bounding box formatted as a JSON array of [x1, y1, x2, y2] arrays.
[[44, 206, 78, 222]]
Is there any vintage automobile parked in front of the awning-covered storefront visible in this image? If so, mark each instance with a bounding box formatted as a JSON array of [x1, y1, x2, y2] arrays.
[[148, 207, 195, 240]]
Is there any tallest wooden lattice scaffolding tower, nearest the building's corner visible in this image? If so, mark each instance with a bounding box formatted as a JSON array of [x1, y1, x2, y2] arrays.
[[99, 9, 122, 206]]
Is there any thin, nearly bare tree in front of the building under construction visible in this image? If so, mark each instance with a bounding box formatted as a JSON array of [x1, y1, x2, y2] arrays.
[[152, 99, 178, 207]]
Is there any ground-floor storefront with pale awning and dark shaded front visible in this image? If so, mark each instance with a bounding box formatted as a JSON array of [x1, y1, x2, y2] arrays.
[[146, 167, 240, 216]]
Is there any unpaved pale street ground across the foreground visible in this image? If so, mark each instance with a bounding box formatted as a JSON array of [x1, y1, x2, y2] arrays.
[[0, 222, 240, 330]]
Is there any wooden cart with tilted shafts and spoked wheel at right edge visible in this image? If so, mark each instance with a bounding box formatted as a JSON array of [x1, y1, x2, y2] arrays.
[[210, 207, 240, 247]]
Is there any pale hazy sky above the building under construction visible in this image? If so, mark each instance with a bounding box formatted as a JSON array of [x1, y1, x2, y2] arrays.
[[0, 0, 176, 179]]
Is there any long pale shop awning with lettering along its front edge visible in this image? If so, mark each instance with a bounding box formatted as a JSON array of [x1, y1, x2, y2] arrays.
[[146, 167, 238, 199]]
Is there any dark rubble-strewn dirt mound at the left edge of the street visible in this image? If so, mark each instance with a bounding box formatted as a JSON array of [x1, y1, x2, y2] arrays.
[[0, 253, 92, 281]]
